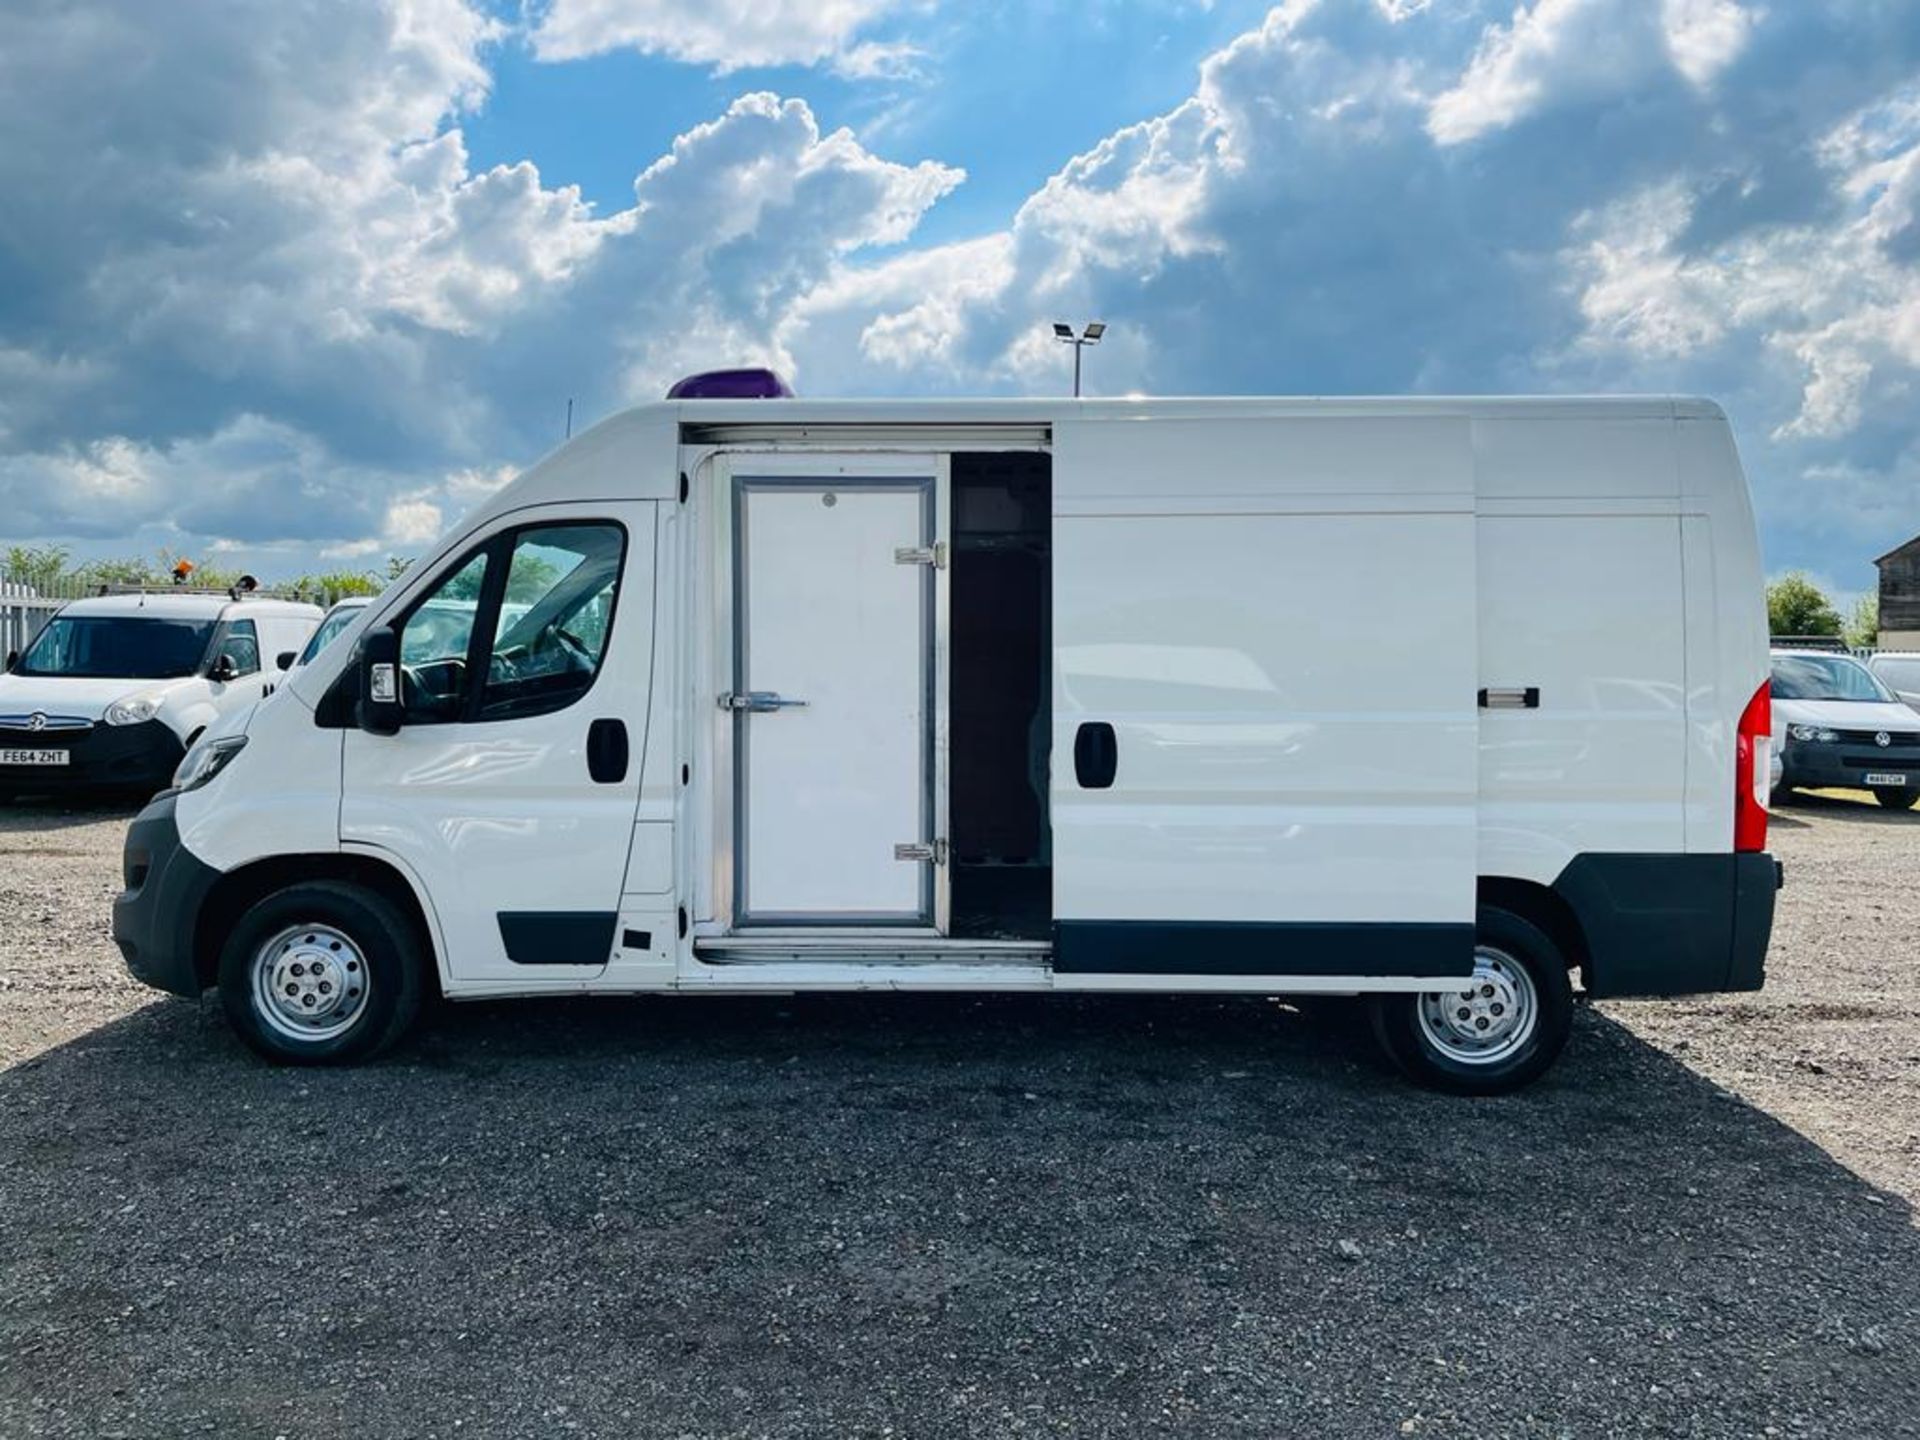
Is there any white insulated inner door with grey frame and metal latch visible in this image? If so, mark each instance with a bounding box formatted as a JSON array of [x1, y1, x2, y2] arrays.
[[728, 474, 935, 925]]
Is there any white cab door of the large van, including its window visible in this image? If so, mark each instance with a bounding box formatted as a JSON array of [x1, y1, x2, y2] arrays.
[[340, 501, 655, 991]]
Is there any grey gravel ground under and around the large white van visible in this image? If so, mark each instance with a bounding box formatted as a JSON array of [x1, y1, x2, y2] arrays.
[[0, 797, 1920, 1440]]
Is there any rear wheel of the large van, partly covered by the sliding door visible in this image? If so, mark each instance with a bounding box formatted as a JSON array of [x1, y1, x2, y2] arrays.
[[1371, 904, 1572, 1094]]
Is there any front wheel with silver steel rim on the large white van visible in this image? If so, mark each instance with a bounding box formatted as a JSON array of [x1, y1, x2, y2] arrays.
[[219, 881, 428, 1066]]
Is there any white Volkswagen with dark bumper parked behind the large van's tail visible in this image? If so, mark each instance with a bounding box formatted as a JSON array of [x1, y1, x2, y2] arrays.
[[1772, 651, 1920, 810]]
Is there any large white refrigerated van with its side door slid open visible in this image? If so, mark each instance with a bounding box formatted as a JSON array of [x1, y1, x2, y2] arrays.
[[113, 384, 1778, 1091]]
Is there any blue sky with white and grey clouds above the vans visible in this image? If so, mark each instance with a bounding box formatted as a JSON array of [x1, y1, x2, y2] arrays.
[[0, 0, 1920, 589]]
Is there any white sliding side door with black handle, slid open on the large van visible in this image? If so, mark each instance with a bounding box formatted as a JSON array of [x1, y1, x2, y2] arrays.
[[1050, 419, 1476, 975]]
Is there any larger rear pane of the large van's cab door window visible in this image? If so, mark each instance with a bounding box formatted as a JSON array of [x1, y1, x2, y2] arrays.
[[480, 524, 626, 720]]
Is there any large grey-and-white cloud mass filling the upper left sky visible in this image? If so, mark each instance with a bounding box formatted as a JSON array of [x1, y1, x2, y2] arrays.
[[0, 0, 960, 547]]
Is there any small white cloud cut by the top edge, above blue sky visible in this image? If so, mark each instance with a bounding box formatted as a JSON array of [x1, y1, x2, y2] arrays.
[[534, 0, 908, 75]]
